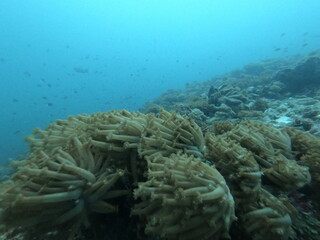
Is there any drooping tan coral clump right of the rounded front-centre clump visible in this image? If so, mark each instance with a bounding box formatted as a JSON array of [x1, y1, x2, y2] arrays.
[[206, 121, 311, 190]]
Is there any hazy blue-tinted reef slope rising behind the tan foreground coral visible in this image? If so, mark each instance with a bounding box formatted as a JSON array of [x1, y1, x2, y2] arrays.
[[141, 50, 320, 136]]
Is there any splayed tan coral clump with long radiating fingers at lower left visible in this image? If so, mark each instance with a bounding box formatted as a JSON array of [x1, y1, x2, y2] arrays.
[[0, 137, 129, 239]]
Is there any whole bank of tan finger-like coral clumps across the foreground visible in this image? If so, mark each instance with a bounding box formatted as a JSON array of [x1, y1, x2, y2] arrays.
[[0, 110, 320, 240]]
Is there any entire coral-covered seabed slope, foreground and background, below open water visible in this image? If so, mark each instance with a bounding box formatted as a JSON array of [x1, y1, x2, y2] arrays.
[[0, 49, 320, 240]]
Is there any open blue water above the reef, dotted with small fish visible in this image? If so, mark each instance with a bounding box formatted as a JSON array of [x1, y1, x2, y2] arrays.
[[0, 0, 320, 161]]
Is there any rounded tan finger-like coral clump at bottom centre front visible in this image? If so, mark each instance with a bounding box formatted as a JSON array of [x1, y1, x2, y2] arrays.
[[132, 154, 235, 239]]
